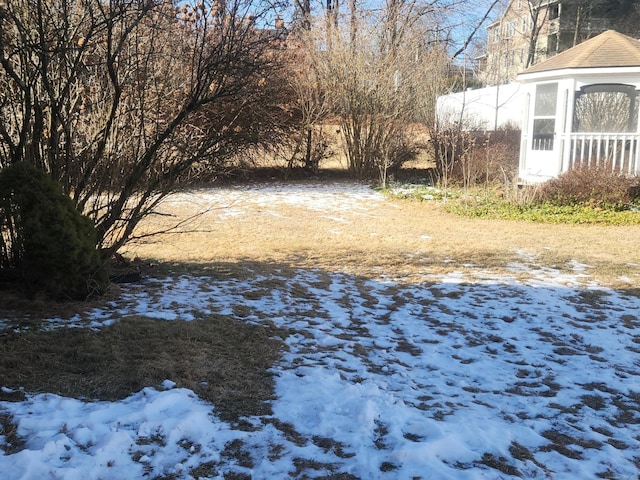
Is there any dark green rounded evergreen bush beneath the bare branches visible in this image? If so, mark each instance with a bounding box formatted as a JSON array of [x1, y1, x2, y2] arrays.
[[0, 163, 108, 299]]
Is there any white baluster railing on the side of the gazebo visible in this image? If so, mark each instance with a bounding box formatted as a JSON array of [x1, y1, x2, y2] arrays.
[[563, 133, 640, 175]]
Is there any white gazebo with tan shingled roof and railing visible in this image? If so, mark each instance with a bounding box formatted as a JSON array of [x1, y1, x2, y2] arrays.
[[518, 30, 640, 183]]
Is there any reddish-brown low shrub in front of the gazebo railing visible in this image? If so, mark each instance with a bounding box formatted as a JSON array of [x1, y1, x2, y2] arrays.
[[539, 165, 640, 210]]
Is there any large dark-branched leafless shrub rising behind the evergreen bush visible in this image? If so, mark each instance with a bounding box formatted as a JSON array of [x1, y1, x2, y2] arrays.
[[0, 0, 288, 253]]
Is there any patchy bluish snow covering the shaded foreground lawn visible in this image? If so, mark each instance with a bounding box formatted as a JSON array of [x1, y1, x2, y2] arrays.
[[0, 182, 640, 480]]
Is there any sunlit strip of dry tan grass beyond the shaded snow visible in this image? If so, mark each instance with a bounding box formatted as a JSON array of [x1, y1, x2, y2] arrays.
[[126, 181, 640, 287]]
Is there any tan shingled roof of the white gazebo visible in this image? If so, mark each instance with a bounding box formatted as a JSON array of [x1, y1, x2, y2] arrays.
[[520, 30, 640, 74]]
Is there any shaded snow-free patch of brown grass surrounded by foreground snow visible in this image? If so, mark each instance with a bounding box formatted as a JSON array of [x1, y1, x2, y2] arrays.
[[0, 316, 282, 420]]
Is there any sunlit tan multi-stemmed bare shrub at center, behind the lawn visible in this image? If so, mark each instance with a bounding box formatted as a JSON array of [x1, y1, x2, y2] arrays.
[[310, 12, 444, 183]]
